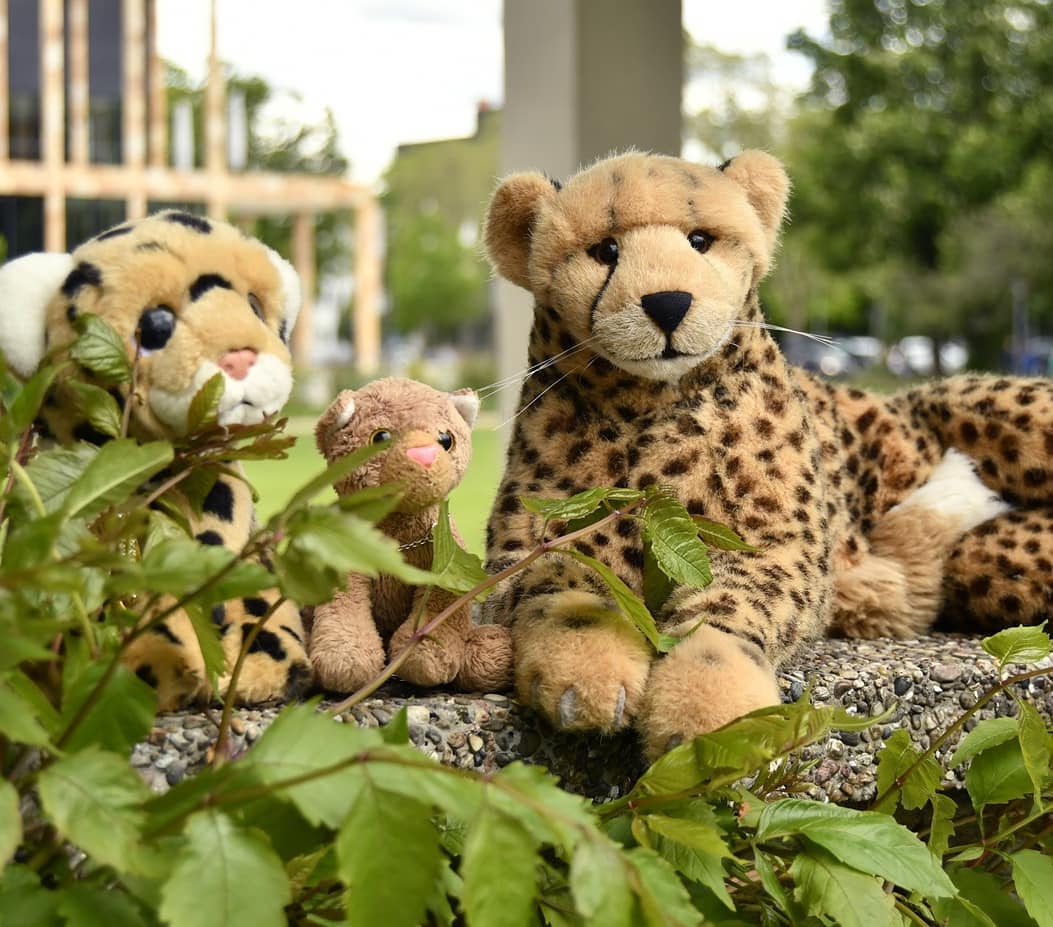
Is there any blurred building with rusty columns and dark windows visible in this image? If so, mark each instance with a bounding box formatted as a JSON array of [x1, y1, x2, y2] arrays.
[[0, 0, 380, 370]]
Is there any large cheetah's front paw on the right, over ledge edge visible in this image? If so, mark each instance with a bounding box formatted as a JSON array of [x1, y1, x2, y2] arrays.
[[638, 626, 780, 760]]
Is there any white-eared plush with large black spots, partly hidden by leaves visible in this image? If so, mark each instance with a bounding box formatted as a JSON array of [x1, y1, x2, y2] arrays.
[[0, 211, 311, 709]]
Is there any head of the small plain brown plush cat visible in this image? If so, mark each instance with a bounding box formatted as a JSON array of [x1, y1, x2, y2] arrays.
[[315, 377, 479, 513]]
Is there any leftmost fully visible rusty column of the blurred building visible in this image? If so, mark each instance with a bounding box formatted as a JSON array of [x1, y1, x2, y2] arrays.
[[40, 0, 66, 251]]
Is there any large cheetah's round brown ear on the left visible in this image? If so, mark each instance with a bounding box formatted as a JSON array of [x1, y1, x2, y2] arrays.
[[483, 172, 557, 290]]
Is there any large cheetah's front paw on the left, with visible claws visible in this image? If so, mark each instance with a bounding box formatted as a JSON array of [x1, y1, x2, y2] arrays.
[[513, 590, 651, 731]]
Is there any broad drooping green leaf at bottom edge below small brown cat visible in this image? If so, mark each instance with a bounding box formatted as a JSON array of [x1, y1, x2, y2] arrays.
[[336, 774, 440, 927]]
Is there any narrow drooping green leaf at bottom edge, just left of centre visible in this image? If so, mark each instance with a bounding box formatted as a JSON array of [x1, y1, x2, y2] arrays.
[[460, 804, 537, 927]]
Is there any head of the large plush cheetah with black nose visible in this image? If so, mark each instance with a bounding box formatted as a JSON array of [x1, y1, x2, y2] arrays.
[[485, 151, 789, 383]]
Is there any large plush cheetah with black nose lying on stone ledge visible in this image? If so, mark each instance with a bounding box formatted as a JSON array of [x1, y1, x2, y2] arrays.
[[485, 152, 1053, 754]]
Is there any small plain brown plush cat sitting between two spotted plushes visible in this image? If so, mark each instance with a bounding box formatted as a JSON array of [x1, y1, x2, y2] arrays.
[[310, 378, 512, 692]]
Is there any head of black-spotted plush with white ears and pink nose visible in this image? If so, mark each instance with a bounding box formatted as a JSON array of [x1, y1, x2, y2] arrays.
[[0, 211, 300, 439]]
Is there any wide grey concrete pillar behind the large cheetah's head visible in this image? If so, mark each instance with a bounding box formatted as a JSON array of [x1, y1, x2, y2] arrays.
[[496, 0, 683, 420]]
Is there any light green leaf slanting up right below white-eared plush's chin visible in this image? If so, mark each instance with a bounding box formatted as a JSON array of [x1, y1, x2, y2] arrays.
[[63, 438, 173, 518]]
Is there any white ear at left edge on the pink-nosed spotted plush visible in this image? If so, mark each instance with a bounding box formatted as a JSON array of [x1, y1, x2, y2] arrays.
[[0, 254, 73, 377]]
